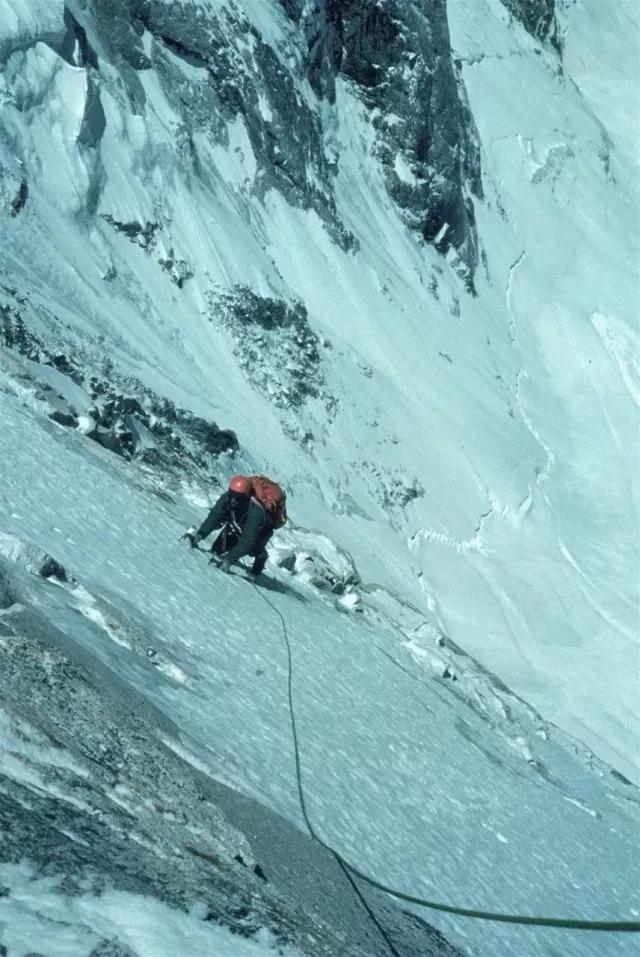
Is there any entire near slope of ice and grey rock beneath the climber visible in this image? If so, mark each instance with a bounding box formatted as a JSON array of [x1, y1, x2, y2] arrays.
[[0, 392, 640, 957]]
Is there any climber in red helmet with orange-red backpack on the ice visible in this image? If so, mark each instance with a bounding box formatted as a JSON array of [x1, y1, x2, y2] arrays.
[[182, 475, 287, 577]]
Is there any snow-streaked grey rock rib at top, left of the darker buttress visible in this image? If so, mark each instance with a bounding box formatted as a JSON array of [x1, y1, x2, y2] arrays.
[[87, 0, 354, 248]]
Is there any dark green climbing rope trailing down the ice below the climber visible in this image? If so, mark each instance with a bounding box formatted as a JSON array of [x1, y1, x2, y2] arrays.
[[252, 582, 640, 932]]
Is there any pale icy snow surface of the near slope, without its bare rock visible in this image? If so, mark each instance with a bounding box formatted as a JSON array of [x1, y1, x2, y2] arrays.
[[0, 386, 638, 957]]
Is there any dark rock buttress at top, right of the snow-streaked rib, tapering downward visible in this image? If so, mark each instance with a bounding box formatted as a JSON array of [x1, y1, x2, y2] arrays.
[[281, 0, 482, 288]]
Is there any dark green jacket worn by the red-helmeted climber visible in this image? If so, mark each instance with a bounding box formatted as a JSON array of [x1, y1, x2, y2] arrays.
[[196, 492, 273, 565]]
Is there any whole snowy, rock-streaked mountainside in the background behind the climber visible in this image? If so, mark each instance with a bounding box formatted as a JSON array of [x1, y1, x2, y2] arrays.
[[0, 0, 640, 940]]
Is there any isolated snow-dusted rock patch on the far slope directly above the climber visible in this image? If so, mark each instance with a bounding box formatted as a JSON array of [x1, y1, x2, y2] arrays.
[[209, 286, 331, 409]]
